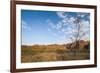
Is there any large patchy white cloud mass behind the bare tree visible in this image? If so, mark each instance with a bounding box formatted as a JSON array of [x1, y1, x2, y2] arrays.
[[48, 12, 90, 40]]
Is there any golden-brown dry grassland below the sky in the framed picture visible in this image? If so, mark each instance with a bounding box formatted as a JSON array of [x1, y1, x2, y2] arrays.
[[21, 42, 90, 63]]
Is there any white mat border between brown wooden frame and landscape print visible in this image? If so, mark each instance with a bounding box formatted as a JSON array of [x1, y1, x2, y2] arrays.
[[16, 5, 94, 69]]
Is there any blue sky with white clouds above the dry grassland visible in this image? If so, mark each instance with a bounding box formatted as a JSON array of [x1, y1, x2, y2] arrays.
[[21, 10, 90, 45]]
